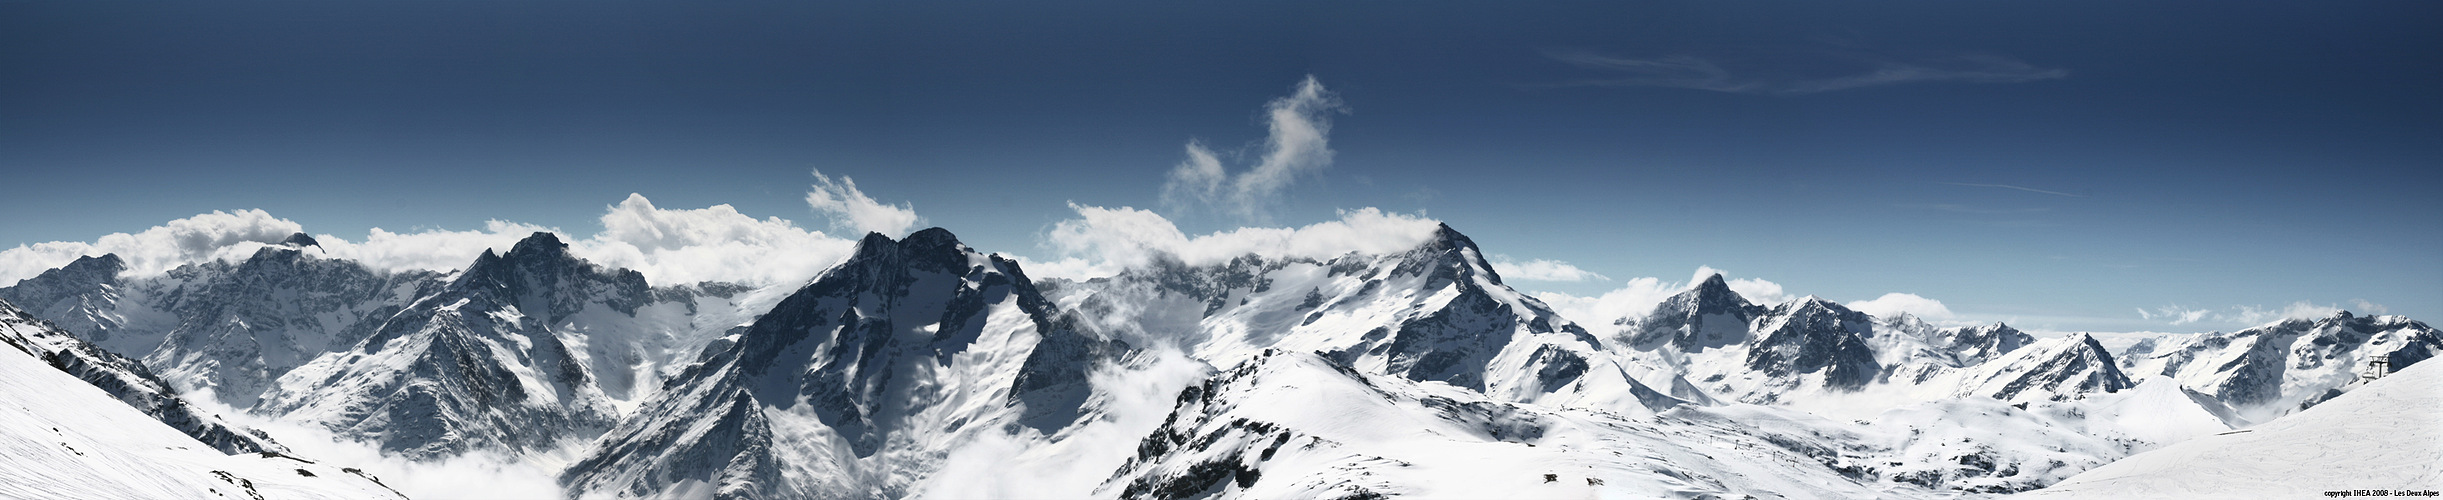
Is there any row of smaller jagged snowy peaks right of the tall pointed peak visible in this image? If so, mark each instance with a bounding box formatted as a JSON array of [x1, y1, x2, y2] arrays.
[[1615, 276, 2130, 415]]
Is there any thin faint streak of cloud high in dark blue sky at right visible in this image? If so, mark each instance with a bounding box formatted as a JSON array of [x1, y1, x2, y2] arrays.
[[1544, 49, 2069, 95]]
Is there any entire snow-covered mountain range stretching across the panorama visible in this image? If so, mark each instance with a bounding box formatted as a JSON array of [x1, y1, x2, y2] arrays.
[[0, 227, 2443, 498]]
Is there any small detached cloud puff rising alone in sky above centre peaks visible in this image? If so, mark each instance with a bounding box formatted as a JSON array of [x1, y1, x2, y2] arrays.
[[1163, 76, 1346, 222]]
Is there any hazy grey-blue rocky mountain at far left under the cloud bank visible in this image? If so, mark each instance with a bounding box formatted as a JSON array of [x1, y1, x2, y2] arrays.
[[0, 234, 442, 407]]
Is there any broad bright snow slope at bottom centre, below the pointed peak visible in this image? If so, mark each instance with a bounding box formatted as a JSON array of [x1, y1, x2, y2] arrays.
[[1099, 351, 1932, 498]]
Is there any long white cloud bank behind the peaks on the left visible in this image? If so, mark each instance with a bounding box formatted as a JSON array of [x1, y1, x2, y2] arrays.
[[0, 190, 855, 285]]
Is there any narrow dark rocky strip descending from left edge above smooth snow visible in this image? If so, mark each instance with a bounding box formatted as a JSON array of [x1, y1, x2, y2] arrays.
[[0, 300, 288, 454]]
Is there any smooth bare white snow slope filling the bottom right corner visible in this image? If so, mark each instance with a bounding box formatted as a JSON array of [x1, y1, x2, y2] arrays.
[[2030, 363, 2443, 498]]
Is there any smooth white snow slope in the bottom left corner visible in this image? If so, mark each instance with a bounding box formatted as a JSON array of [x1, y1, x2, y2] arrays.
[[0, 305, 403, 500]]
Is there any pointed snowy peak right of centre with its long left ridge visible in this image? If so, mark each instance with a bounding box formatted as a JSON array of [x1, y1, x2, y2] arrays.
[[1048, 227, 1683, 412]]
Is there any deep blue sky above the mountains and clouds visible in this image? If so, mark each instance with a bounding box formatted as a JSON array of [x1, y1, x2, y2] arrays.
[[0, 2, 2443, 332]]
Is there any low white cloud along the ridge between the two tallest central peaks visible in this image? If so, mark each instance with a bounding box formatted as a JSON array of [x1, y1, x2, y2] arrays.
[[1024, 202, 1441, 278]]
